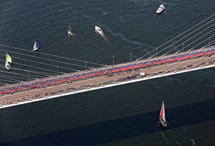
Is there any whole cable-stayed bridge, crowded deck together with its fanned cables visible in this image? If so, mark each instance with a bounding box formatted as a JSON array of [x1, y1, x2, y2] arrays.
[[0, 14, 215, 108]]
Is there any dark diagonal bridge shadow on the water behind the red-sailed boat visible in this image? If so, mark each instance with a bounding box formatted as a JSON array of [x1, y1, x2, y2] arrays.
[[5, 100, 215, 146]]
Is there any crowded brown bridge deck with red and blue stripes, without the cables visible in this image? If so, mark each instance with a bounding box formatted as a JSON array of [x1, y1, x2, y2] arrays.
[[0, 47, 215, 108]]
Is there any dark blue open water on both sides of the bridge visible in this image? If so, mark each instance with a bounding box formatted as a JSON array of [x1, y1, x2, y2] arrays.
[[0, 0, 215, 146]]
